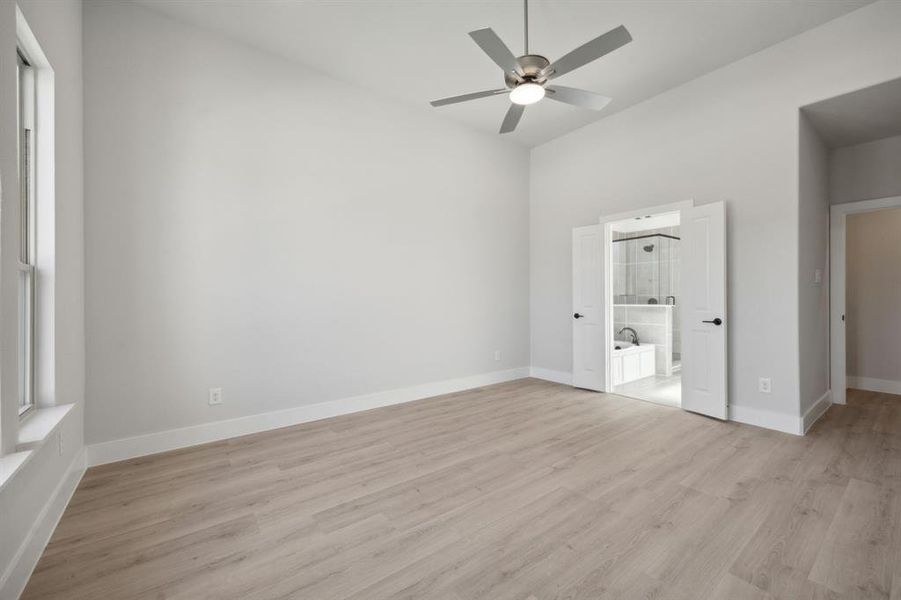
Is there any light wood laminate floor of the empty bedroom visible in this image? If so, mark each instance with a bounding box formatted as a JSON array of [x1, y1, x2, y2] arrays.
[[24, 379, 901, 600]]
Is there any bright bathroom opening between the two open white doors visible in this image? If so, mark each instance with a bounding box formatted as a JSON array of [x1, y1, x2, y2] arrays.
[[607, 212, 682, 407]]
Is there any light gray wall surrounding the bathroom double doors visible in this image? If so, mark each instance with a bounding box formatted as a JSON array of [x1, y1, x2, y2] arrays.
[[530, 2, 901, 426]]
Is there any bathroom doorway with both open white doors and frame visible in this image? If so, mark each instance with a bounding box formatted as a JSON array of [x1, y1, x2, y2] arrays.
[[571, 200, 729, 419]]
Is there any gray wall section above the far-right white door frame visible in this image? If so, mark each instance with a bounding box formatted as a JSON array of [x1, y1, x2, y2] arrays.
[[829, 136, 901, 204]]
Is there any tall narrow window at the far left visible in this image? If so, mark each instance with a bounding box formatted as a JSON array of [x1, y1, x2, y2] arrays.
[[18, 50, 37, 416]]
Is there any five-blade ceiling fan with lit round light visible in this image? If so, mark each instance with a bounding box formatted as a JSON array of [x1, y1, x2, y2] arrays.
[[431, 0, 632, 133]]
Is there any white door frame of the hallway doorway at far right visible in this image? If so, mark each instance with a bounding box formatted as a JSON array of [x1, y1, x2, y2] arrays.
[[829, 196, 901, 404]]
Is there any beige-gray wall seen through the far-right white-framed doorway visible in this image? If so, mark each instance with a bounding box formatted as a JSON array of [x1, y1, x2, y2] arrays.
[[845, 209, 901, 384]]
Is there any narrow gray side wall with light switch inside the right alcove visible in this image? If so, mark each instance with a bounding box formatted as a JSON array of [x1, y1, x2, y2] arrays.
[[798, 112, 830, 414]]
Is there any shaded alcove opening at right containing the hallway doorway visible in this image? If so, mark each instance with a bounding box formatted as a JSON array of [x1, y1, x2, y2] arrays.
[[798, 78, 901, 412]]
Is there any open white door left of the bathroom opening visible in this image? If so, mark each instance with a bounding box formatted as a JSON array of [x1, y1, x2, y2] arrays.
[[572, 225, 607, 392]]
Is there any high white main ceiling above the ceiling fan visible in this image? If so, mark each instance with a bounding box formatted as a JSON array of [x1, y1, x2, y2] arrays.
[[137, 0, 871, 146]]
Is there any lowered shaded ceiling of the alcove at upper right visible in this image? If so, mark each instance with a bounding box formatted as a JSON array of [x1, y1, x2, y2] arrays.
[[804, 79, 901, 148]]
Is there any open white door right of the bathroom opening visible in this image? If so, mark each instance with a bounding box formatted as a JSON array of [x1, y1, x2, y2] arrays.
[[682, 202, 728, 419]]
